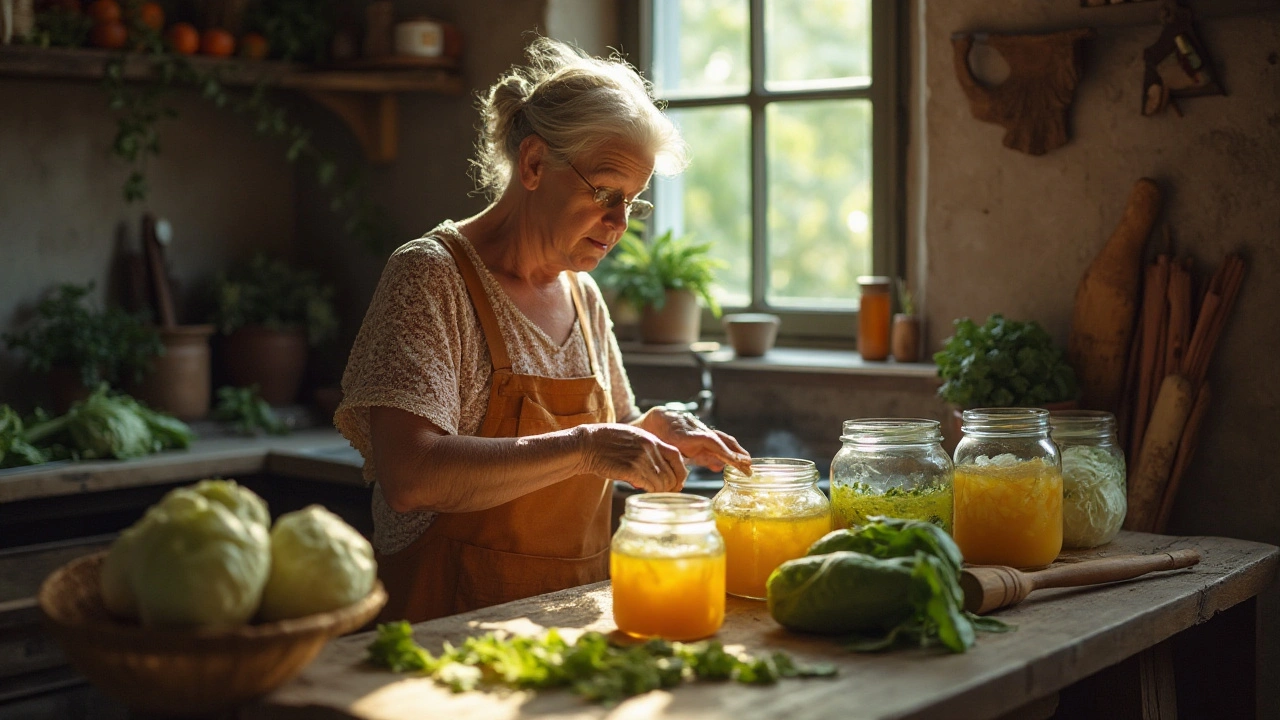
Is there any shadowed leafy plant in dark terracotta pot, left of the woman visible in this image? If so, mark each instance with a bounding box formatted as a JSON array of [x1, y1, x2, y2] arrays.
[[214, 255, 338, 406]]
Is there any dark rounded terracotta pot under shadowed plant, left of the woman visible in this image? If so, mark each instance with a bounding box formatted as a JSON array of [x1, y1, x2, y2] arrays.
[[220, 325, 307, 406]]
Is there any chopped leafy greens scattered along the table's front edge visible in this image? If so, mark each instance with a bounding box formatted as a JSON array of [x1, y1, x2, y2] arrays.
[[369, 621, 836, 705]]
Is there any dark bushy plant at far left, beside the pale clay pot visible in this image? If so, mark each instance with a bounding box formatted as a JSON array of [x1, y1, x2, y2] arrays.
[[4, 282, 164, 413]]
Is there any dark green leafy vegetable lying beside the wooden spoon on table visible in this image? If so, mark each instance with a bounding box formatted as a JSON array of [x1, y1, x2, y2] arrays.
[[769, 518, 1009, 652]]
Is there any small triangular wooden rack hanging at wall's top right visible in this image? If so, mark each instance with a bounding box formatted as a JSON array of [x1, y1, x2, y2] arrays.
[[1142, 0, 1226, 117]]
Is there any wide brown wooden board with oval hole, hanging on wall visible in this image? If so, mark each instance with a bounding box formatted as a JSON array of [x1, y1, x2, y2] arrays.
[[951, 28, 1094, 155]]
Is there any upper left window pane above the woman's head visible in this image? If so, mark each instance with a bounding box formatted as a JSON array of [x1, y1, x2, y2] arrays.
[[653, 0, 751, 97]]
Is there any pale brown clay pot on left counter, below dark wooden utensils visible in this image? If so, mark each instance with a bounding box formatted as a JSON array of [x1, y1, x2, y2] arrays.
[[129, 325, 214, 420]]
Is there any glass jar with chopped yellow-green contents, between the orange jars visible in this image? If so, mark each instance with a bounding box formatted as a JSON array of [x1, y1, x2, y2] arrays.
[[831, 418, 952, 533]]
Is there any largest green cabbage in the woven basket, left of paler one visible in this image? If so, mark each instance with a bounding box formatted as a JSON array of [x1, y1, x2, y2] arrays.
[[128, 488, 271, 626]]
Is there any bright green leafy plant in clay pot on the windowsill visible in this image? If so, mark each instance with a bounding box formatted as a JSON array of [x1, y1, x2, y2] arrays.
[[595, 223, 723, 345]]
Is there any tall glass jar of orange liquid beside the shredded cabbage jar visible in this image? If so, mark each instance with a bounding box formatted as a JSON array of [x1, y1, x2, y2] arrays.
[[952, 407, 1062, 568]]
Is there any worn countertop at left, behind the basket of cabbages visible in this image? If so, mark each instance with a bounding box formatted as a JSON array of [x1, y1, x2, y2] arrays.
[[0, 428, 364, 503]]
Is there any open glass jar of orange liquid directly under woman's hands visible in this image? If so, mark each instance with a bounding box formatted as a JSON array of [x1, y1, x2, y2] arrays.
[[712, 457, 831, 600]]
